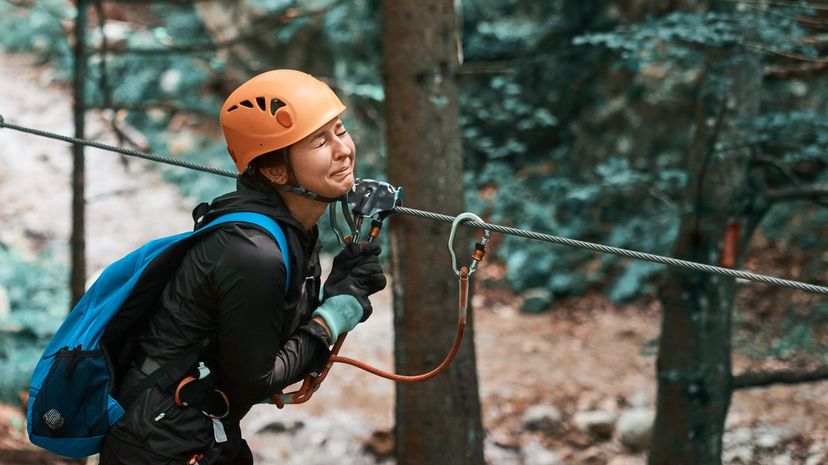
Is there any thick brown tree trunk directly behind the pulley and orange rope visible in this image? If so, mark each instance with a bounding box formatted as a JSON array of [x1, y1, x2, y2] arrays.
[[382, 0, 484, 465]]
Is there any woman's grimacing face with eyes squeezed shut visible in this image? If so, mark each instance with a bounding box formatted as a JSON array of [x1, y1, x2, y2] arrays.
[[288, 117, 356, 197]]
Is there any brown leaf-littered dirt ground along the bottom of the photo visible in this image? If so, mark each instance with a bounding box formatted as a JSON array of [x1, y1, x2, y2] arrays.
[[0, 295, 828, 465]]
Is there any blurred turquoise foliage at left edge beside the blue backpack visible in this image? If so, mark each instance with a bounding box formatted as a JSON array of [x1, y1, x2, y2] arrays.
[[0, 245, 69, 402]]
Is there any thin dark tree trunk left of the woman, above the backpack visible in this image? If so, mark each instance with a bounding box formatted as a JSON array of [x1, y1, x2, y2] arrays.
[[69, 0, 88, 308]]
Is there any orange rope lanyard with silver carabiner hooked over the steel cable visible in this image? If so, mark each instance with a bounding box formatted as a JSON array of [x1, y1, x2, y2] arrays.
[[272, 208, 491, 408]]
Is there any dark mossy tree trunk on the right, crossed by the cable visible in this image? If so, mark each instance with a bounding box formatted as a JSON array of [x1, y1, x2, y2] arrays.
[[649, 50, 762, 465]]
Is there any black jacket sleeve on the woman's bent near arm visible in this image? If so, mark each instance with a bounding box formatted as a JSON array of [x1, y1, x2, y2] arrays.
[[211, 225, 329, 418]]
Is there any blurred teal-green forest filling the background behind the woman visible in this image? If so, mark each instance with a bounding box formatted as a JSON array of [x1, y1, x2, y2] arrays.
[[0, 0, 828, 463]]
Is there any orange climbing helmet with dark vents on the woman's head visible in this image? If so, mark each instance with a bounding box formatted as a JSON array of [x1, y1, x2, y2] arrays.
[[220, 69, 345, 173]]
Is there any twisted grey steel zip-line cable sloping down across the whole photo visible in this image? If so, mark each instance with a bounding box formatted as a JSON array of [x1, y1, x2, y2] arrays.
[[0, 115, 828, 295]]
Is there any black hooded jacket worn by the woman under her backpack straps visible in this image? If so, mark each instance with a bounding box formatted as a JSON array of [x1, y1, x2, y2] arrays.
[[105, 176, 330, 459]]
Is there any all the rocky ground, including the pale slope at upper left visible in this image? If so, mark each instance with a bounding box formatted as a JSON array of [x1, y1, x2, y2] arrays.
[[0, 50, 828, 465]]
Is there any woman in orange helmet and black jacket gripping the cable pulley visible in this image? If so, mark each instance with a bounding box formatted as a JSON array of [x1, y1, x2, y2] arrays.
[[100, 70, 386, 464]]
